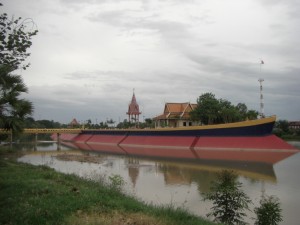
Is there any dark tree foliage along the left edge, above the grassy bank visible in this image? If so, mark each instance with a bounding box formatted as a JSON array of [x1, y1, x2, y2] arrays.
[[0, 4, 37, 131]]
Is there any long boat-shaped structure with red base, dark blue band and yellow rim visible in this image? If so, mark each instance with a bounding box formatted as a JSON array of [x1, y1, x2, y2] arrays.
[[53, 116, 299, 164]]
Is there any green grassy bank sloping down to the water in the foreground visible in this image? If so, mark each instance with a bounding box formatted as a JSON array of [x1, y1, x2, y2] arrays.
[[0, 155, 218, 225]]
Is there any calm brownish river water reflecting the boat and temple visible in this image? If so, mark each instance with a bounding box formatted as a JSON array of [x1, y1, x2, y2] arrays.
[[9, 142, 300, 225]]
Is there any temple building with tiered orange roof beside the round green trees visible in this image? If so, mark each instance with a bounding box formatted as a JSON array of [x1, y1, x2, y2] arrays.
[[153, 102, 199, 127]]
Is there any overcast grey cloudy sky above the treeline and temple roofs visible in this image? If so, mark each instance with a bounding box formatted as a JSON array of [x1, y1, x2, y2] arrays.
[[1, 0, 300, 123]]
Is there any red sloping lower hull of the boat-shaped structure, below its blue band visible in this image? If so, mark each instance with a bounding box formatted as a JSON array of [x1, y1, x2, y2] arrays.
[[53, 134, 299, 164]]
